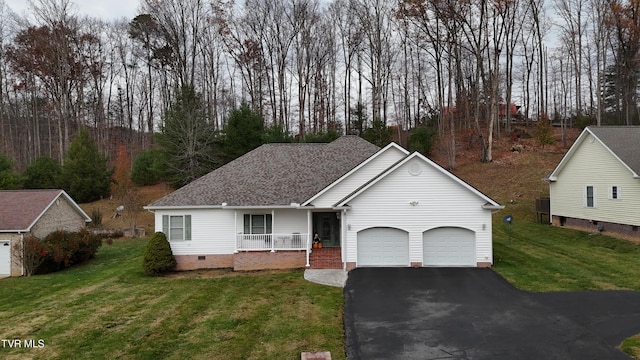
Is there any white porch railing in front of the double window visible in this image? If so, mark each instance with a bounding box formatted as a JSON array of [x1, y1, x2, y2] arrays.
[[236, 233, 311, 251]]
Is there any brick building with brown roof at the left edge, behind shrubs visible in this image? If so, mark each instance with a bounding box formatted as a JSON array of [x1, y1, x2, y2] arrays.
[[0, 190, 91, 276]]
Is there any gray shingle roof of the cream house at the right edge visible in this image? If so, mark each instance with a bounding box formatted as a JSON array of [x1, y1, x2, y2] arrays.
[[589, 126, 640, 174]]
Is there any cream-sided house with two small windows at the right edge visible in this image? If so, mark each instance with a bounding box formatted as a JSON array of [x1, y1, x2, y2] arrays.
[[546, 126, 640, 239]]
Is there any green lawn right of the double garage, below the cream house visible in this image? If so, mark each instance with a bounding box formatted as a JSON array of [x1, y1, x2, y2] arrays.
[[493, 220, 640, 292]]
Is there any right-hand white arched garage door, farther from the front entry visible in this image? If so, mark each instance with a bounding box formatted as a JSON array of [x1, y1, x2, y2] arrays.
[[422, 227, 476, 267]]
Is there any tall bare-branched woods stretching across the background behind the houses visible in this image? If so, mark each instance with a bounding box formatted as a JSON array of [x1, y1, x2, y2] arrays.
[[0, 0, 640, 170]]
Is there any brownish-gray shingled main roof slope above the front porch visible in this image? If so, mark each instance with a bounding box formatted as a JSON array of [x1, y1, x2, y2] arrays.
[[149, 136, 380, 208]]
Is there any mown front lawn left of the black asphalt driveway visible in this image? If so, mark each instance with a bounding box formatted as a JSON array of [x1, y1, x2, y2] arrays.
[[0, 239, 344, 359]]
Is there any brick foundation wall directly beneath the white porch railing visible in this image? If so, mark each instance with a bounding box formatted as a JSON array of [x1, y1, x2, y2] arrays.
[[233, 251, 307, 271]]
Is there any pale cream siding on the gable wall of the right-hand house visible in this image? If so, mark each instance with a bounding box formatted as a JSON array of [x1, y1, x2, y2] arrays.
[[549, 135, 640, 226]]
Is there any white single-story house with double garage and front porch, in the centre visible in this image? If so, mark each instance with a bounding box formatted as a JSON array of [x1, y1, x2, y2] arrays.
[[145, 136, 503, 270]]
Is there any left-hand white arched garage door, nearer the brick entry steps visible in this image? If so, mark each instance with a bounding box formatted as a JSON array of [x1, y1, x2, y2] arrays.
[[357, 228, 409, 266]]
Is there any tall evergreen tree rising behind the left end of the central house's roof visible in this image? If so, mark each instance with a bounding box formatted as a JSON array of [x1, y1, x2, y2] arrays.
[[156, 86, 219, 186]]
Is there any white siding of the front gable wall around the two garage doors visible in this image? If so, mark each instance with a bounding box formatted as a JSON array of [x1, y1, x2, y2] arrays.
[[345, 159, 493, 263]]
